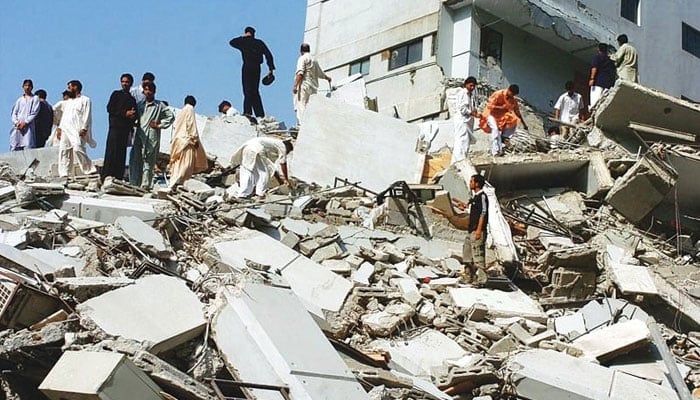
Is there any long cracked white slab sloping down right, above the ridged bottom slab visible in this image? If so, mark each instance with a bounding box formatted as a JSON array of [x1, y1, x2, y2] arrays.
[[214, 230, 353, 318]]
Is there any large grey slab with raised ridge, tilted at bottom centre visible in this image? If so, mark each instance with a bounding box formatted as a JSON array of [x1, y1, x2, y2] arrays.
[[212, 284, 368, 400]]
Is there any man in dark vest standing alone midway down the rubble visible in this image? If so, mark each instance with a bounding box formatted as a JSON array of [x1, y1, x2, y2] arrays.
[[462, 174, 489, 283]]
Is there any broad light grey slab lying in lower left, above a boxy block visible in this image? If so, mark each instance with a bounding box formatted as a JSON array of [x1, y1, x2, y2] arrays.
[[76, 275, 205, 354]]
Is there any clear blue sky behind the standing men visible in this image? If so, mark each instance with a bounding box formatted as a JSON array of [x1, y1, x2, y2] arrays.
[[0, 0, 306, 158]]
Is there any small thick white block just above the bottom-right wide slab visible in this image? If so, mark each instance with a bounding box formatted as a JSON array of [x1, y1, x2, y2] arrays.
[[573, 319, 651, 362]]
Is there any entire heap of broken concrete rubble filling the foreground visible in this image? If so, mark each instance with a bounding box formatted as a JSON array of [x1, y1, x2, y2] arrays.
[[0, 79, 700, 400]]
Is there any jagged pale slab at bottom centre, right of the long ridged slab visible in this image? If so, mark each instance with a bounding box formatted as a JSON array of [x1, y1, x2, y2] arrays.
[[369, 329, 479, 378]]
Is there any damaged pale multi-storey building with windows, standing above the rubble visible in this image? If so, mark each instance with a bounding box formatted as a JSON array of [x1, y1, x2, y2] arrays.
[[304, 0, 700, 121]]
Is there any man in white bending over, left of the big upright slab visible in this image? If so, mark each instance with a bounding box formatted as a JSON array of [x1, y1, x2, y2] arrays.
[[231, 137, 294, 198]]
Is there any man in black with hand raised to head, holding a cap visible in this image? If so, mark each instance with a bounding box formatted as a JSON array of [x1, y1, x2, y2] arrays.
[[228, 26, 275, 118]]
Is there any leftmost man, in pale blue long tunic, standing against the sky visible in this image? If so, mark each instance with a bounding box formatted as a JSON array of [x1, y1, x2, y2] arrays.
[[10, 79, 39, 151]]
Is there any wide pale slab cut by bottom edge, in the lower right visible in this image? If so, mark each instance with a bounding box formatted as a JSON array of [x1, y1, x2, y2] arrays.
[[503, 349, 677, 400]]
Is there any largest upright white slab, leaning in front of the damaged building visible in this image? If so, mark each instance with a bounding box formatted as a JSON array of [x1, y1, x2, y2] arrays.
[[290, 96, 425, 191]]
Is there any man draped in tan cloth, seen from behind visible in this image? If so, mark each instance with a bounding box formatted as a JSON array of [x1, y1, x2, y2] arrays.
[[170, 104, 208, 187]]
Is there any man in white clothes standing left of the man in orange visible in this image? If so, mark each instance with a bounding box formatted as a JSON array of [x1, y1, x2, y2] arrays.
[[450, 76, 480, 164]]
